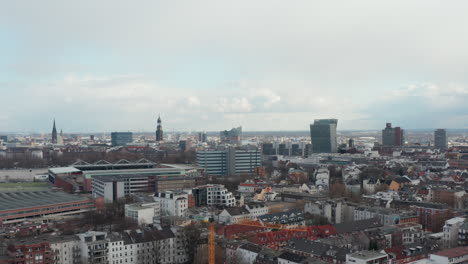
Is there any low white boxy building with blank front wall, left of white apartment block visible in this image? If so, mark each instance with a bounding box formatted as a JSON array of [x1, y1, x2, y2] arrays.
[[125, 202, 161, 225]]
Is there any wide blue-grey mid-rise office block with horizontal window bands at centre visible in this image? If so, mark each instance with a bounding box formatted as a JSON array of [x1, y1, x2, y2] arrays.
[[197, 147, 262, 176]]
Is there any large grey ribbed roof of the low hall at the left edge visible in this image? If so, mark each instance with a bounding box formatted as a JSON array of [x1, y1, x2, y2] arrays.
[[0, 191, 89, 211]]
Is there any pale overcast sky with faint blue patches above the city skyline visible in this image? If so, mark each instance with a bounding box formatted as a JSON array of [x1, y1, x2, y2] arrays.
[[0, 0, 468, 133]]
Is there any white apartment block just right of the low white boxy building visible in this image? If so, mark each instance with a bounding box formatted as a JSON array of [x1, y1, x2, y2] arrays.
[[153, 191, 188, 216]]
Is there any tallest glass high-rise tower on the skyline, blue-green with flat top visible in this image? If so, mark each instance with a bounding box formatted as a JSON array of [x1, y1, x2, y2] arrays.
[[310, 119, 338, 153]]
